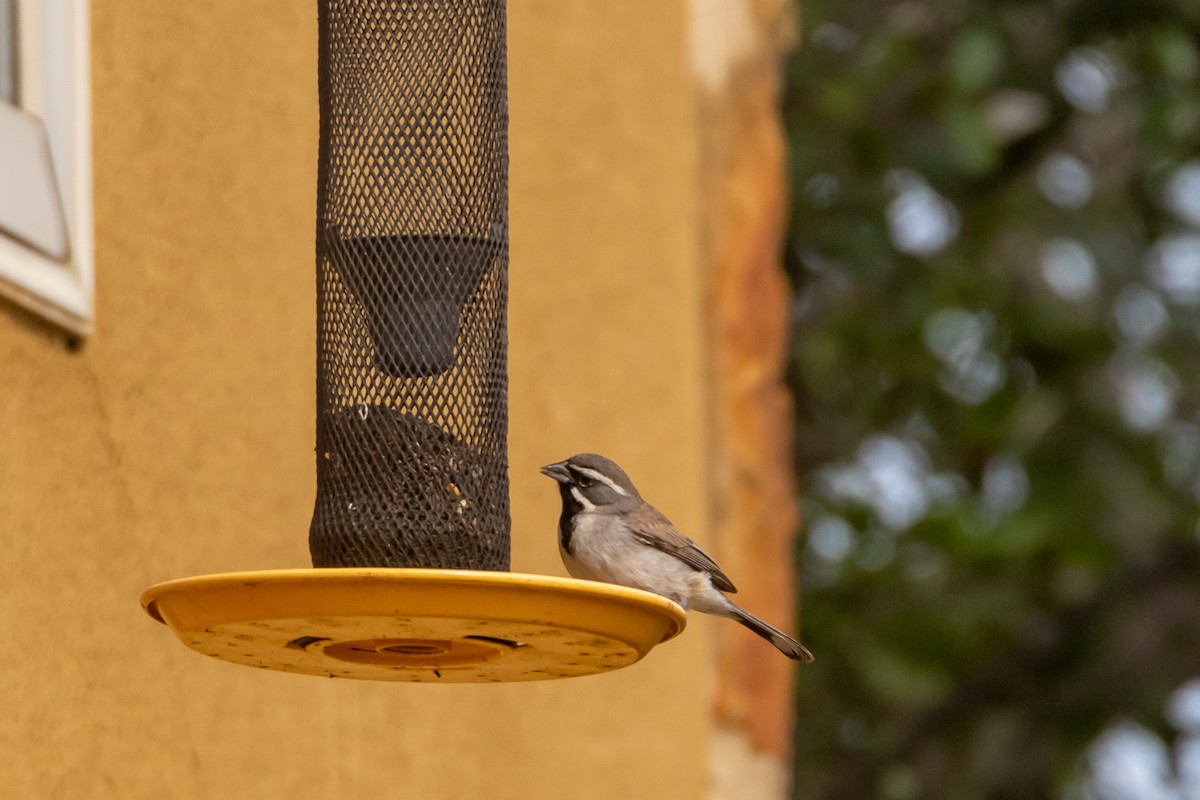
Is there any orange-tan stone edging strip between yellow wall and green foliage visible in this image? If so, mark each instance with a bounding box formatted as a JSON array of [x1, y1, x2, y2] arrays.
[[691, 0, 798, 800]]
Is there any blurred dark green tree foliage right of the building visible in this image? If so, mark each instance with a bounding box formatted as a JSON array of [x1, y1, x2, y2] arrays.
[[785, 0, 1200, 800]]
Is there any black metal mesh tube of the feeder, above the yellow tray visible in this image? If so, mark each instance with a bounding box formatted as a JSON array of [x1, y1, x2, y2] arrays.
[[308, 0, 510, 570]]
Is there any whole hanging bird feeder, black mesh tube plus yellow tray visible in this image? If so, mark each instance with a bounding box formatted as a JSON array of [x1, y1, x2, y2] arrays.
[[142, 0, 685, 682]]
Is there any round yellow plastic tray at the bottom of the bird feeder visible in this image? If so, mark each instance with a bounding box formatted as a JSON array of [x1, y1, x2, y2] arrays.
[[142, 569, 686, 684]]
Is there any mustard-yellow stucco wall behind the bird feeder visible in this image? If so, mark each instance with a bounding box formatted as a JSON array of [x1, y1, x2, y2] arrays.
[[0, 0, 713, 800]]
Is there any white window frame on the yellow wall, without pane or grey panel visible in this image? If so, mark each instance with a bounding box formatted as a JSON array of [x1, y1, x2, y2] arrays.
[[0, 0, 95, 336]]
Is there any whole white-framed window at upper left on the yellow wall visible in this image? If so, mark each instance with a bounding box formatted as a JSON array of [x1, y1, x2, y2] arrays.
[[0, 0, 92, 335]]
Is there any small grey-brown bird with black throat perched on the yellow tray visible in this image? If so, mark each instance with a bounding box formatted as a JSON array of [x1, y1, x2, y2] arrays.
[[541, 453, 812, 663]]
